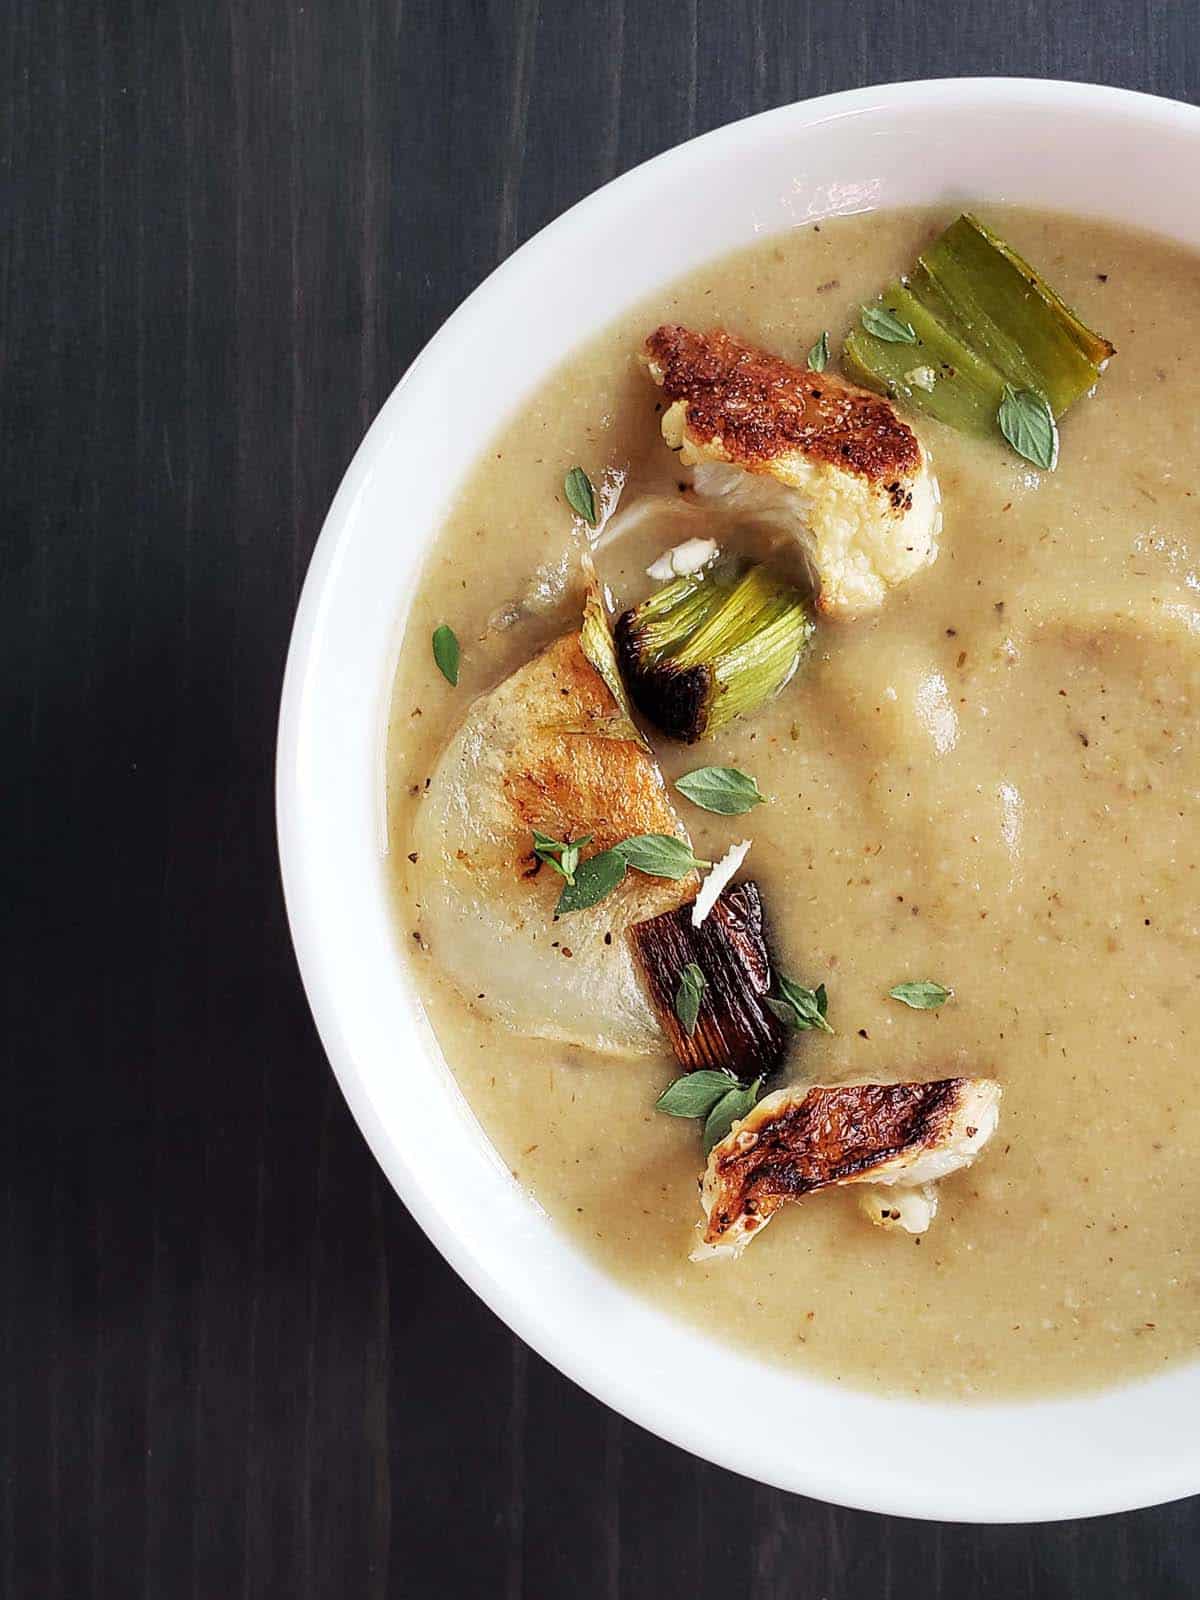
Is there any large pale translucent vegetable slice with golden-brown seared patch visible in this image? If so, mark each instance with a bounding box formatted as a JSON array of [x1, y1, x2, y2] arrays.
[[411, 632, 699, 1054]]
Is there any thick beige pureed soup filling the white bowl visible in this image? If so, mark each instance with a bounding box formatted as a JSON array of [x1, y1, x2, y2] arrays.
[[389, 208, 1200, 1397]]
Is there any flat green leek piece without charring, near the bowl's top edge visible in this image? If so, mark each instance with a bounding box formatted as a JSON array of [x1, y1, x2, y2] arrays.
[[843, 213, 1114, 437]]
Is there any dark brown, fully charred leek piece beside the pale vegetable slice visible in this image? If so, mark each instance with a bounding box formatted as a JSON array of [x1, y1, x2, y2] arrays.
[[629, 882, 789, 1083]]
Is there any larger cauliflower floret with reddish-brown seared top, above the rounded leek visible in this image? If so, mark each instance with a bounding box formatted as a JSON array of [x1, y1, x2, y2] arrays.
[[643, 325, 941, 616]]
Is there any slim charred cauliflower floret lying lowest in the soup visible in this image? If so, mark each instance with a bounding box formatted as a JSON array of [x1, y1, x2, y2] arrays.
[[693, 1078, 1000, 1261]]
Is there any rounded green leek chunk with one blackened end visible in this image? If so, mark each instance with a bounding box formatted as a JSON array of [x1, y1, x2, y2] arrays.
[[616, 565, 814, 744]]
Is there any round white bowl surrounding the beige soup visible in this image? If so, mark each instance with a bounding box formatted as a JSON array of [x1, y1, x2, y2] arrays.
[[277, 78, 1200, 1522]]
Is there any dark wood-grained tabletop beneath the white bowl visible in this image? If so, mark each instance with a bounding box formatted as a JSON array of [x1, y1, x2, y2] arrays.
[[9, 0, 1200, 1600]]
